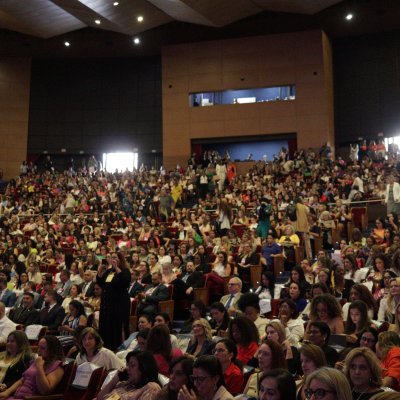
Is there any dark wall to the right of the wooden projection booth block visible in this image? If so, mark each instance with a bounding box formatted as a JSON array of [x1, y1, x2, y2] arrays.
[[333, 32, 400, 146]]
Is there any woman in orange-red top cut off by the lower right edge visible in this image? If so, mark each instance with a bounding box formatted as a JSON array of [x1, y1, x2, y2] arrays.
[[376, 332, 400, 392]]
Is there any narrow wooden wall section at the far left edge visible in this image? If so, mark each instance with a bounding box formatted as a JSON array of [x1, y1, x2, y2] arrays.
[[0, 58, 31, 179]]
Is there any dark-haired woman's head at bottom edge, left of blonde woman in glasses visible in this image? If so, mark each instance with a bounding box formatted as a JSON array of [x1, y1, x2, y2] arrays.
[[260, 368, 296, 400]]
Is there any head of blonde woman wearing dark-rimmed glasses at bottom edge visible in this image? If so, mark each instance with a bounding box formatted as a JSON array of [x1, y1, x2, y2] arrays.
[[304, 367, 352, 400]]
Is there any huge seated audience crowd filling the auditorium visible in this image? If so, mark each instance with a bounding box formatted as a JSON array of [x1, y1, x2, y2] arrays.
[[0, 141, 400, 400]]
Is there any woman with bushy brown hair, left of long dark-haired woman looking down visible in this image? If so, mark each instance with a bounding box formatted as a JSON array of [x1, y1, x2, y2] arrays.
[[306, 294, 344, 339]]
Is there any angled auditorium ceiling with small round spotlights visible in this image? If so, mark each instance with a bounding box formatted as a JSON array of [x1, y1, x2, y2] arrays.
[[0, 0, 400, 58]]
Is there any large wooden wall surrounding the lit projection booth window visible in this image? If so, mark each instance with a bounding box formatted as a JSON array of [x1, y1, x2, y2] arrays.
[[162, 31, 334, 168]]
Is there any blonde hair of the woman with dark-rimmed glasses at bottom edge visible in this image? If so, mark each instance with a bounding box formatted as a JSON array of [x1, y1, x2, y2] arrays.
[[306, 367, 353, 400]]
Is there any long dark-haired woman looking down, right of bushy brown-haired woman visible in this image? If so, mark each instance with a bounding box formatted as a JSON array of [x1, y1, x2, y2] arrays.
[[344, 300, 376, 344]]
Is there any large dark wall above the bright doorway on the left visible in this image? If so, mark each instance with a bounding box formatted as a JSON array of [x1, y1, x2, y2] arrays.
[[28, 57, 162, 160]]
